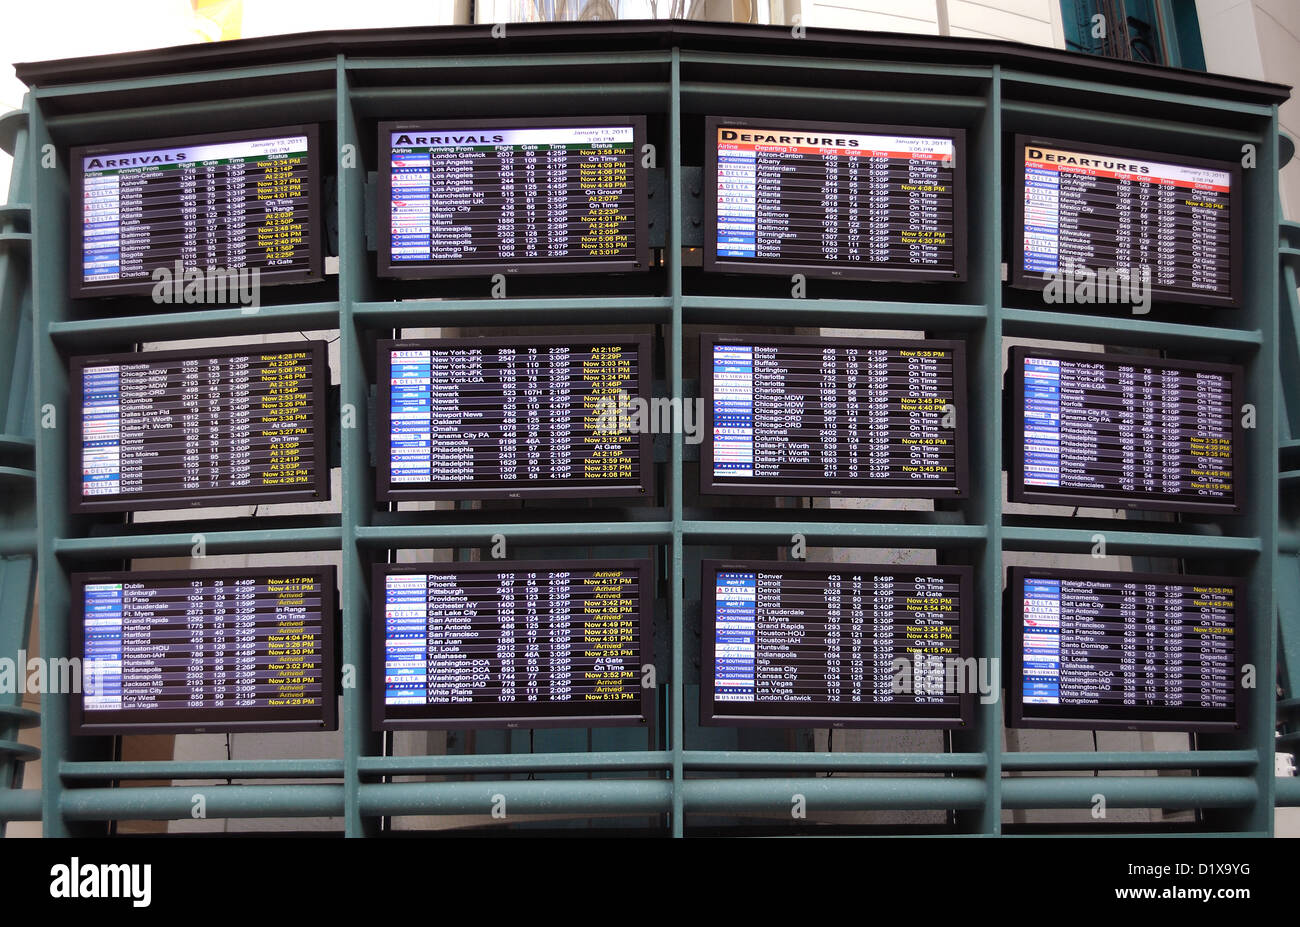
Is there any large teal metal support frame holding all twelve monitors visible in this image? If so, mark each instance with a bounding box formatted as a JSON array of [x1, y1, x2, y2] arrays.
[[0, 25, 1300, 837]]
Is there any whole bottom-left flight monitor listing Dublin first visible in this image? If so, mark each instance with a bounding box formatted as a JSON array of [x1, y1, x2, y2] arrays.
[[72, 566, 338, 733]]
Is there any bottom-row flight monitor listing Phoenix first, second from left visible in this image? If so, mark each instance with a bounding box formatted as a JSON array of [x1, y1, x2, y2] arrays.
[[372, 560, 655, 729]]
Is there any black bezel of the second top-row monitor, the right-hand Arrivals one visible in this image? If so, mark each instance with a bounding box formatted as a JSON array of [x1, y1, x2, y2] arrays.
[[376, 116, 650, 280]]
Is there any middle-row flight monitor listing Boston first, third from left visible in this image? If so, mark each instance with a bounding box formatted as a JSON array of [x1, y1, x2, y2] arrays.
[[699, 334, 967, 498]]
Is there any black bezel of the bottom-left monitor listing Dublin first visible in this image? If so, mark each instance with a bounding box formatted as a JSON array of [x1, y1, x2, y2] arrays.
[[69, 564, 339, 735]]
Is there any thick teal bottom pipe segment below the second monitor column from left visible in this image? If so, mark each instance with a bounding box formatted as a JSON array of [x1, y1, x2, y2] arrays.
[[360, 779, 672, 820]]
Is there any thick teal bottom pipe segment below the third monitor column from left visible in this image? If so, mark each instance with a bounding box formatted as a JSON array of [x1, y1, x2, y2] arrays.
[[681, 777, 988, 814]]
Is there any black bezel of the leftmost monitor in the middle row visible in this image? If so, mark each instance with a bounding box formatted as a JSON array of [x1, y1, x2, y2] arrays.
[[68, 341, 330, 514]]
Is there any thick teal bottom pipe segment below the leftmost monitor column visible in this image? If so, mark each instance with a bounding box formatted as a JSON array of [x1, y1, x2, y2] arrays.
[[60, 785, 343, 820]]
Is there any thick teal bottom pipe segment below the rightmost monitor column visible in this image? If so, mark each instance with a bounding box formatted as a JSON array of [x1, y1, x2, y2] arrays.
[[1002, 776, 1260, 809]]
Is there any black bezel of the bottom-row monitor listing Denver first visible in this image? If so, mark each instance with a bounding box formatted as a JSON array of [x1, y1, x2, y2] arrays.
[[699, 559, 975, 729]]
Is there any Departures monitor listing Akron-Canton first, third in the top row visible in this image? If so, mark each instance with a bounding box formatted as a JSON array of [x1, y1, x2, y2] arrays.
[[703, 116, 966, 281]]
